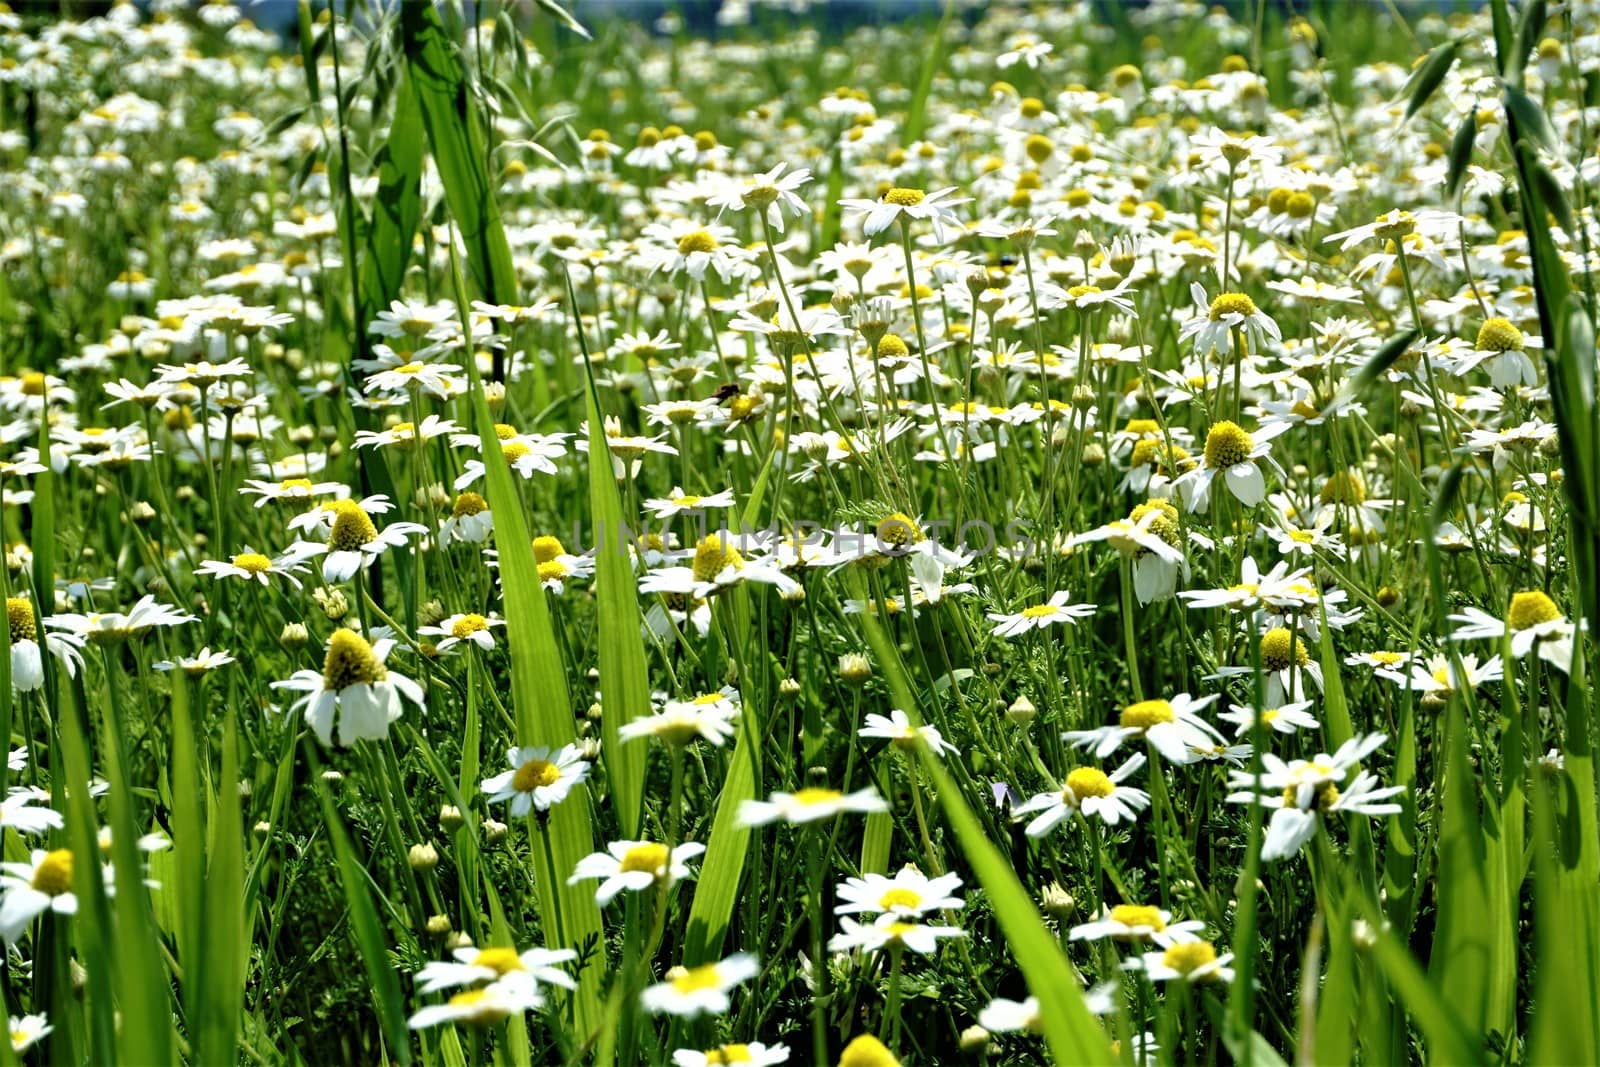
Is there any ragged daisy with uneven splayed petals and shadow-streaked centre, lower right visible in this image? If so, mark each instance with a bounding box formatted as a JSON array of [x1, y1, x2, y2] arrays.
[[1227, 734, 1405, 862]]
